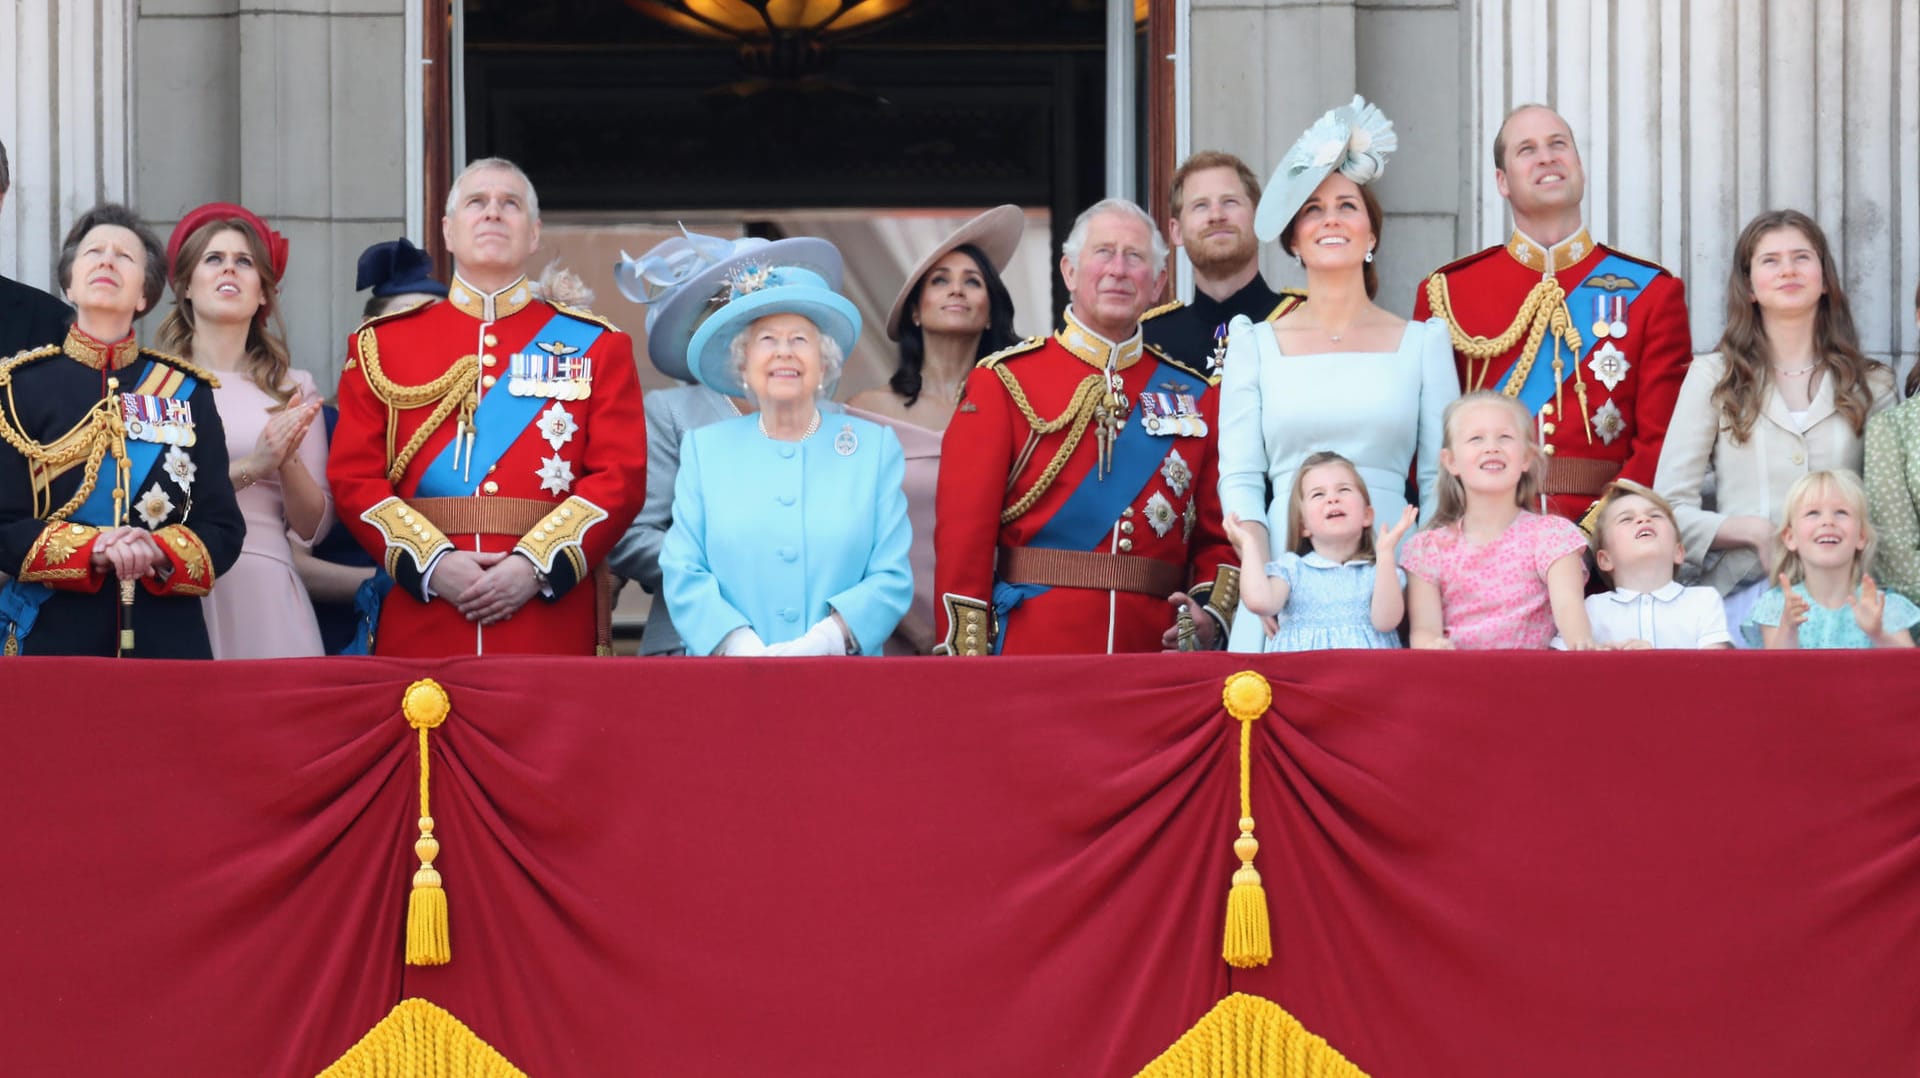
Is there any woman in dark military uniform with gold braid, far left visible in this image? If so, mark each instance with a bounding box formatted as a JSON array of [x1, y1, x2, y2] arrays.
[[0, 204, 244, 659]]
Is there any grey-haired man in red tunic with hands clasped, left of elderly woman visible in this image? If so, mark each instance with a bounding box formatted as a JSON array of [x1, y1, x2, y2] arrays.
[[326, 158, 647, 657]]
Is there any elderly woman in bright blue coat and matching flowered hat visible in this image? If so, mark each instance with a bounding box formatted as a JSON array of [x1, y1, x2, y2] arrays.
[[660, 265, 914, 655]]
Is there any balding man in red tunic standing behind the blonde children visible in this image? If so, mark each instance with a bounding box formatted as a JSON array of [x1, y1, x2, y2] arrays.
[[1413, 106, 1693, 523]]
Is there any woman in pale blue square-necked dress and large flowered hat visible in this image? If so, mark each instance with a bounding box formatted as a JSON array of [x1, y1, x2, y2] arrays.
[[1219, 96, 1459, 651]]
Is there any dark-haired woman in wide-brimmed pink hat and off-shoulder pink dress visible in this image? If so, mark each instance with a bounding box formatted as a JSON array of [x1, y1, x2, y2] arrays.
[[847, 206, 1027, 655]]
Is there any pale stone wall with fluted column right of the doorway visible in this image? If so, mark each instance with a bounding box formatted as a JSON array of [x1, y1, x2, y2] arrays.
[[1187, 0, 1920, 361]]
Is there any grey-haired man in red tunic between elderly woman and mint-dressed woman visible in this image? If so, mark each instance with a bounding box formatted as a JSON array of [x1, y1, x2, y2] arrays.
[[933, 200, 1240, 655]]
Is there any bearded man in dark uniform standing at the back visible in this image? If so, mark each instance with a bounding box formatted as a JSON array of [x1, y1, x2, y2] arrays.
[[1140, 150, 1304, 375]]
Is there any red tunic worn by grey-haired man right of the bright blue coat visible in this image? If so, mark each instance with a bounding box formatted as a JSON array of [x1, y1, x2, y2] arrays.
[[933, 311, 1238, 655]]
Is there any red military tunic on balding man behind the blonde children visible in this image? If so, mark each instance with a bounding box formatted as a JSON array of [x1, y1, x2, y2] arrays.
[[1413, 229, 1693, 521]]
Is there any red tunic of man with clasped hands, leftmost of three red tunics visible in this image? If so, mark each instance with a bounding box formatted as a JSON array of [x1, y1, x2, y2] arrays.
[[326, 277, 647, 657]]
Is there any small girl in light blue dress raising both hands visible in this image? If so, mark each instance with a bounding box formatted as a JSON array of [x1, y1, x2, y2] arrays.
[[1227, 453, 1419, 651]]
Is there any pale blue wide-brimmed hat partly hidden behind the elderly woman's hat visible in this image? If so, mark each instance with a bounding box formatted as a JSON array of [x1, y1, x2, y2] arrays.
[[612, 229, 843, 382]]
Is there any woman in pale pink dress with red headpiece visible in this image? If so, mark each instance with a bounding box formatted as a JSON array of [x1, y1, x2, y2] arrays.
[[159, 202, 334, 659]]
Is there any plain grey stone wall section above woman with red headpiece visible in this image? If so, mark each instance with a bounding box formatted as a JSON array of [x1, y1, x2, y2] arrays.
[[132, 0, 412, 392]]
